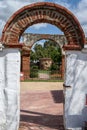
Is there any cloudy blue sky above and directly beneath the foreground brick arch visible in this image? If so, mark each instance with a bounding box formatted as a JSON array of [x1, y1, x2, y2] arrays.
[[0, 0, 87, 37]]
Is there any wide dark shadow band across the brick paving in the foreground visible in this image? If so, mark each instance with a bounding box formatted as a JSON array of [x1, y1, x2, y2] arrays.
[[20, 110, 64, 130]]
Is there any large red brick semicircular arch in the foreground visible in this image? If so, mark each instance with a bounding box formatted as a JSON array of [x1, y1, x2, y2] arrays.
[[1, 2, 85, 50]]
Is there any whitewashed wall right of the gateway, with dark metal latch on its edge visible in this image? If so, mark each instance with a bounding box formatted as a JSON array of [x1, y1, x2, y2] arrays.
[[64, 51, 87, 130]]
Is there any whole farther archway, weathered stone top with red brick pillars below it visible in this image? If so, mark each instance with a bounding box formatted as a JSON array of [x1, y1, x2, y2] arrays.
[[21, 33, 67, 79]]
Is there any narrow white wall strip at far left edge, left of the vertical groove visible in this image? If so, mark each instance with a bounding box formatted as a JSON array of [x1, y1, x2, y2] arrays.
[[0, 51, 6, 130]]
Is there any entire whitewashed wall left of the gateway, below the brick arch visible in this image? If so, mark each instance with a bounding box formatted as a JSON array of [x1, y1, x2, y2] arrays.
[[0, 49, 20, 130]]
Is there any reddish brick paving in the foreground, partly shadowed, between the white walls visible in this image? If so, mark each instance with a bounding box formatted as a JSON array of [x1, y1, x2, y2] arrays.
[[19, 90, 64, 130]]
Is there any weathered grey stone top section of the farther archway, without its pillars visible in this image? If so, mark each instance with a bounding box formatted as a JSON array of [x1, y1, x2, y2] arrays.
[[22, 33, 67, 51]]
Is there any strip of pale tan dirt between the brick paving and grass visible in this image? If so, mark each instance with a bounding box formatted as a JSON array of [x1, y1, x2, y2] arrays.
[[21, 82, 63, 92]]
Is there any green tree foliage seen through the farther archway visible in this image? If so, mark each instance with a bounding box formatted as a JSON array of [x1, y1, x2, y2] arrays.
[[30, 40, 62, 63]]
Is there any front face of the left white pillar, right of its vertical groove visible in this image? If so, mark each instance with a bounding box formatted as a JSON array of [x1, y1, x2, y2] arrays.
[[5, 49, 20, 130]]
